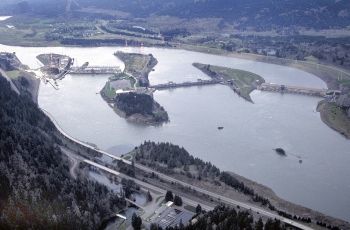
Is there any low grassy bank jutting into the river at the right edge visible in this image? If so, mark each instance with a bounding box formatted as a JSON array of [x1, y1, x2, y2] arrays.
[[317, 101, 350, 138]]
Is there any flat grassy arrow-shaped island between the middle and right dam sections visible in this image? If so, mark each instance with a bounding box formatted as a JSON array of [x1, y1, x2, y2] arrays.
[[193, 63, 265, 101]]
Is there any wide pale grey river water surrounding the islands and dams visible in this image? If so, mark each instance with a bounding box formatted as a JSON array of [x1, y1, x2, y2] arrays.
[[0, 45, 350, 221]]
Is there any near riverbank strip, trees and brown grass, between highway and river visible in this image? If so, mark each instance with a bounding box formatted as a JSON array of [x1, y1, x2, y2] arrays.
[[131, 142, 350, 229]]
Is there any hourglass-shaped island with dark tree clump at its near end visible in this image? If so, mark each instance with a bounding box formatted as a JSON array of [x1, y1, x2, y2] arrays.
[[101, 52, 169, 125]]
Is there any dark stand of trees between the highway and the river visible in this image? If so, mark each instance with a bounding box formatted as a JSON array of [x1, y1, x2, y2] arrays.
[[135, 141, 275, 210]]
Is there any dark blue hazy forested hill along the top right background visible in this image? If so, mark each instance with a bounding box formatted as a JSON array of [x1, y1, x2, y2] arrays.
[[162, 0, 350, 29]]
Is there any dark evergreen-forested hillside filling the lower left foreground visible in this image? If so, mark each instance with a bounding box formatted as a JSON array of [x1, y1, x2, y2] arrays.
[[0, 77, 124, 229]]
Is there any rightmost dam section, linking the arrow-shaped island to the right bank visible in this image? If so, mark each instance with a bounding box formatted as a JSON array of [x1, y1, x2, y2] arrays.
[[257, 83, 328, 97]]
